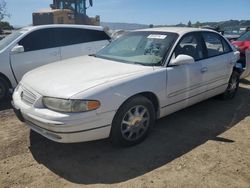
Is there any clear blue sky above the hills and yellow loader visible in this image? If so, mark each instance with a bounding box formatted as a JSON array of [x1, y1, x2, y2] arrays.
[[0, 0, 250, 26]]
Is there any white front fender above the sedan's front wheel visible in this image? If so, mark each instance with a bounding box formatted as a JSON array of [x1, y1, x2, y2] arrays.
[[75, 67, 167, 113]]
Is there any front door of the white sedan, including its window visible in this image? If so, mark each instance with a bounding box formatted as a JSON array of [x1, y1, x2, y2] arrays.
[[165, 33, 206, 114]]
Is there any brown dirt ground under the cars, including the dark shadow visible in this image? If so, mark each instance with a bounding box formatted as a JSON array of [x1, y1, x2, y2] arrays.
[[0, 80, 250, 188]]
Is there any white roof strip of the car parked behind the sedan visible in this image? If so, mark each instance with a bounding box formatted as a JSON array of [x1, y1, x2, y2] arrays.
[[21, 24, 104, 31]]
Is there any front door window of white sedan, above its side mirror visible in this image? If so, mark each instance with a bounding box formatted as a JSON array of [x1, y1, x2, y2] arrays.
[[174, 34, 203, 61]]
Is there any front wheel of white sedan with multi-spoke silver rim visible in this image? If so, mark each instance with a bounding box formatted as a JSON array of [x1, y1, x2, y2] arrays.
[[110, 96, 155, 146]]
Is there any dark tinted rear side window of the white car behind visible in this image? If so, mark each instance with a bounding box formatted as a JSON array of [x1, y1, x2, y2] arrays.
[[58, 28, 110, 46]]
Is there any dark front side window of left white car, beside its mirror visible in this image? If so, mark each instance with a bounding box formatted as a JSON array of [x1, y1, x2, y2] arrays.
[[18, 28, 59, 52]]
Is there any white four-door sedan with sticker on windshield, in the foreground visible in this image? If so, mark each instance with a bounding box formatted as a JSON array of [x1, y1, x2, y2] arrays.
[[13, 28, 241, 146]]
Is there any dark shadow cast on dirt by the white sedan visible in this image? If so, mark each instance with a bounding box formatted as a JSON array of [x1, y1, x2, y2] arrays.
[[30, 88, 250, 185]]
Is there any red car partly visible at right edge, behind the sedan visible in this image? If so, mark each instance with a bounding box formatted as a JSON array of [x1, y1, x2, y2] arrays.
[[232, 31, 250, 67]]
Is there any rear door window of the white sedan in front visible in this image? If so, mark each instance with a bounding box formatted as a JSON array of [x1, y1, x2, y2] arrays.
[[202, 32, 226, 57]]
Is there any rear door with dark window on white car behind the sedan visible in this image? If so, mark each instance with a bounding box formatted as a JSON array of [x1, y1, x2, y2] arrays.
[[58, 28, 109, 59]]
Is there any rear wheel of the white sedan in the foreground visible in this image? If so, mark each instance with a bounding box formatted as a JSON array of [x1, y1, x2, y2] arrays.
[[221, 71, 240, 100]]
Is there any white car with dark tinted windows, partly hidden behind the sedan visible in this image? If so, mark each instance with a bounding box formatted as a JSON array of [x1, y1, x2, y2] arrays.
[[0, 25, 110, 100]]
